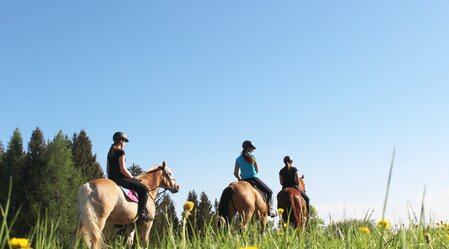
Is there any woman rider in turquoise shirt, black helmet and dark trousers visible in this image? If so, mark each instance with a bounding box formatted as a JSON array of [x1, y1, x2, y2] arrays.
[[234, 140, 276, 217]]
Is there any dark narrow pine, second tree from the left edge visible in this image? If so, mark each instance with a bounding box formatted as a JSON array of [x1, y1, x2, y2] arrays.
[[19, 128, 47, 232]]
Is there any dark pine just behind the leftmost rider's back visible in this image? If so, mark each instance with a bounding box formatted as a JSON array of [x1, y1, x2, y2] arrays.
[[71, 130, 104, 182]]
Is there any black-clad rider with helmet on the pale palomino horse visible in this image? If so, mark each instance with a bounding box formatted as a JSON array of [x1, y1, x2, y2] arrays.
[[107, 132, 149, 222]]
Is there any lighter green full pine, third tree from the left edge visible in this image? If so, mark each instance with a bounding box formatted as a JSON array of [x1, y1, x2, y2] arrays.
[[42, 131, 82, 246]]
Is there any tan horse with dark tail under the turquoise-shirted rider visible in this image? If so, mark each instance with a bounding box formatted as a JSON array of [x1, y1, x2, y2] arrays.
[[218, 181, 268, 231]]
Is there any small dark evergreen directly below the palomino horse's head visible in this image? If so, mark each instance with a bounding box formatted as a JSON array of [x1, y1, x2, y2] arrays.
[[150, 193, 179, 241]]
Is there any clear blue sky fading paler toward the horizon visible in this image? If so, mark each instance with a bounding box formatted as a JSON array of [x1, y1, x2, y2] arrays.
[[0, 0, 449, 224]]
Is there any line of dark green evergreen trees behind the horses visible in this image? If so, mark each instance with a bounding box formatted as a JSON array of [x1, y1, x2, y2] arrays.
[[0, 128, 218, 245]]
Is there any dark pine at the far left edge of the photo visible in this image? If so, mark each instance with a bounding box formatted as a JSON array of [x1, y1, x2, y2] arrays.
[[0, 128, 26, 236]]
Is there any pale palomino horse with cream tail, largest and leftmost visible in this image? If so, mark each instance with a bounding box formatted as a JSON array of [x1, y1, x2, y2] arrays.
[[78, 162, 179, 249]]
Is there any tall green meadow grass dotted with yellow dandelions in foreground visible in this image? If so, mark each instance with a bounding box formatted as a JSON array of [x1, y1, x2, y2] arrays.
[[0, 151, 449, 249]]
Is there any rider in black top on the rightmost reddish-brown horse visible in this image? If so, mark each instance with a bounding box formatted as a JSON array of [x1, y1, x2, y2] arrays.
[[279, 156, 310, 214]]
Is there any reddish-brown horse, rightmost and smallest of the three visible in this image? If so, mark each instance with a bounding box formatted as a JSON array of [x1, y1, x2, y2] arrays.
[[277, 177, 308, 228]]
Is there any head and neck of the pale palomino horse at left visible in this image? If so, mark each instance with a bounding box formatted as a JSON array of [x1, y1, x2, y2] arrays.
[[142, 161, 179, 193]]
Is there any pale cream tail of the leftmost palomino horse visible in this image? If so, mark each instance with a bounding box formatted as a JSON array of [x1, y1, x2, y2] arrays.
[[77, 183, 106, 248]]
